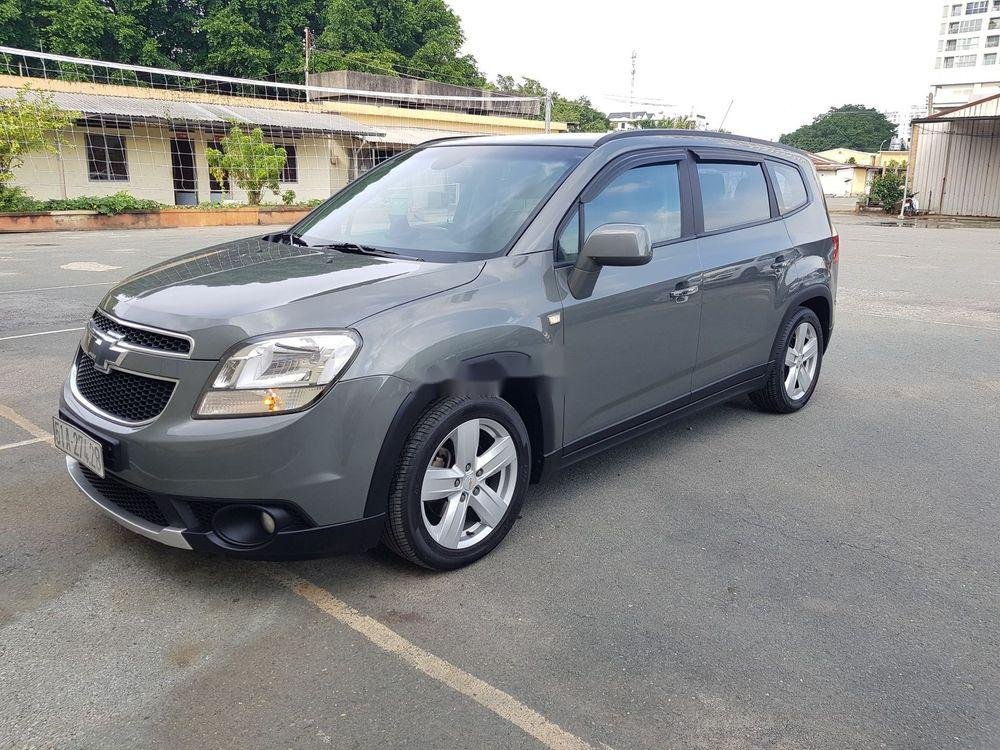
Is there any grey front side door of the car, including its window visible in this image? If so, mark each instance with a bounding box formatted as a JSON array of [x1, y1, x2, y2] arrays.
[[557, 153, 701, 451]]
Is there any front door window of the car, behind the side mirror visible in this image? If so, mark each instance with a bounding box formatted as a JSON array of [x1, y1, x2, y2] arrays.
[[557, 163, 681, 260]]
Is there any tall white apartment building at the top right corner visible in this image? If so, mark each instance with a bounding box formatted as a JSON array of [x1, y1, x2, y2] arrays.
[[931, 0, 1000, 112]]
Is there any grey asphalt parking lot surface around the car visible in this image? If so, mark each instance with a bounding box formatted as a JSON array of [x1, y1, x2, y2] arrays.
[[0, 217, 1000, 749]]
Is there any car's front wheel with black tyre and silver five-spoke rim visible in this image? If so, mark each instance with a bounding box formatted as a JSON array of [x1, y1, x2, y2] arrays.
[[383, 397, 531, 570]]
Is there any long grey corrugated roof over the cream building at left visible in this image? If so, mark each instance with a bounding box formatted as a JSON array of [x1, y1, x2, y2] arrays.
[[0, 87, 382, 136]]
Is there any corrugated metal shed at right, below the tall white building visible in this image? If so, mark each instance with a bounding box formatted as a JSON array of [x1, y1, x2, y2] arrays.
[[910, 94, 1000, 218]]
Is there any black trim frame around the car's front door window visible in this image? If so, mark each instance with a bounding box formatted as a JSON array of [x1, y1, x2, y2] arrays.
[[551, 147, 696, 268]]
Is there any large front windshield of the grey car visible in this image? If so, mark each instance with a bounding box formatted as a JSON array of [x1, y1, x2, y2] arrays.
[[294, 146, 588, 261]]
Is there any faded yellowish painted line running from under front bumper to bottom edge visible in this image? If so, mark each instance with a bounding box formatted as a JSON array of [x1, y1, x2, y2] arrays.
[[271, 567, 592, 750]]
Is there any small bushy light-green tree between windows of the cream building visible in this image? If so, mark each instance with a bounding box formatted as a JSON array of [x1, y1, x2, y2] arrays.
[[205, 125, 287, 206]]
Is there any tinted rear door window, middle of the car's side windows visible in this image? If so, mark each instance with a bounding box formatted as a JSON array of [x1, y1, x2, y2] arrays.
[[698, 163, 771, 232]]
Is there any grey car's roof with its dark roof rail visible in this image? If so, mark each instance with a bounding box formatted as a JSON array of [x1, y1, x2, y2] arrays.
[[424, 129, 808, 162]]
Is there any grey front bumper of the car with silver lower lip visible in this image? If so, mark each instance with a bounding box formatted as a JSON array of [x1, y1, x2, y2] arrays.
[[60, 358, 410, 558]]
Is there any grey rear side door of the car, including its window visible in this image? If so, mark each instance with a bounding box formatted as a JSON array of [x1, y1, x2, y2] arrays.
[[692, 149, 793, 396]]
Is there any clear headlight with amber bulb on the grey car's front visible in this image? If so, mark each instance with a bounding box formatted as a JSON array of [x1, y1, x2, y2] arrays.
[[195, 331, 361, 417]]
